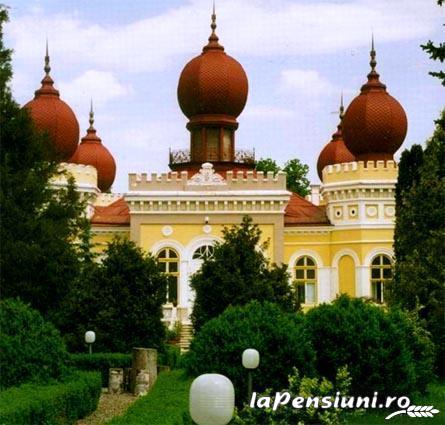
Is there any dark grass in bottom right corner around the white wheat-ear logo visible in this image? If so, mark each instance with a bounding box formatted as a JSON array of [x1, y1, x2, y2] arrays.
[[348, 381, 445, 425]]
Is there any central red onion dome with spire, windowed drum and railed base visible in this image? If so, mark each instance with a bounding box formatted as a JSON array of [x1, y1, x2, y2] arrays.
[[170, 7, 254, 172]]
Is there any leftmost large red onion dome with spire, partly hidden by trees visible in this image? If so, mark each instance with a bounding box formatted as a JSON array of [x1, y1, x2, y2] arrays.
[[24, 43, 79, 161]]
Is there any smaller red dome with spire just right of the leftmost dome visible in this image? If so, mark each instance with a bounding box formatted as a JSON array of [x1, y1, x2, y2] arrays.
[[69, 103, 116, 192]]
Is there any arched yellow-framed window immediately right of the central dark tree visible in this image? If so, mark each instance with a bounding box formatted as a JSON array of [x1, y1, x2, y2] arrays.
[[295, 256, 317, 304]]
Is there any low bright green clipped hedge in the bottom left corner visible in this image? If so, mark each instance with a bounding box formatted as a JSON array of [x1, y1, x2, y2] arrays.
[[0, 372, 102, 425]]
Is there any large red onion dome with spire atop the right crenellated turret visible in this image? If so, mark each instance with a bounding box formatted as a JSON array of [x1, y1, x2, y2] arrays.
[[343, 38, 408, 161]]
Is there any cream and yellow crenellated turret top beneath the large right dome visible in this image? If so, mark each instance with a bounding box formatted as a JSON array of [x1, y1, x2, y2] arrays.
[[321, 161, 398, 227]]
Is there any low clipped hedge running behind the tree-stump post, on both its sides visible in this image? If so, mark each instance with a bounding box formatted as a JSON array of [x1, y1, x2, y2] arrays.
[[68, 345, 181, 387]]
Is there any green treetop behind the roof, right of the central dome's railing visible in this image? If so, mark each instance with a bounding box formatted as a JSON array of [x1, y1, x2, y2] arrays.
[[255, 158, 310, 196]]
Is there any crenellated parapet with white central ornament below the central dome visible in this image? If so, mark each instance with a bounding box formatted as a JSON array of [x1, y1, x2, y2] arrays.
[[129, 164, 286, 191]]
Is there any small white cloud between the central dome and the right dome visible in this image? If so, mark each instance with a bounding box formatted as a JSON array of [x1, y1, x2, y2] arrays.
[[281, 69, 340, 98]]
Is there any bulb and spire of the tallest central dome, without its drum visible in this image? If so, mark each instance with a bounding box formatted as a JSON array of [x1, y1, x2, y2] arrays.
[[178, 12, 248, 121]]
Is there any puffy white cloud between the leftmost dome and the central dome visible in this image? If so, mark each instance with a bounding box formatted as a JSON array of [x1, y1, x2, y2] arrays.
[[58, 69, 131, 107]]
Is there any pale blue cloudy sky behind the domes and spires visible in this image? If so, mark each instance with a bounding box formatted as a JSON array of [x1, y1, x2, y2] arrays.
[[5, 0, 445, 192]]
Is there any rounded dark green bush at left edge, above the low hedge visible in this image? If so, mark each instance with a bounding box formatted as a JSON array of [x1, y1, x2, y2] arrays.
[[0, 299, 68, 388]]
